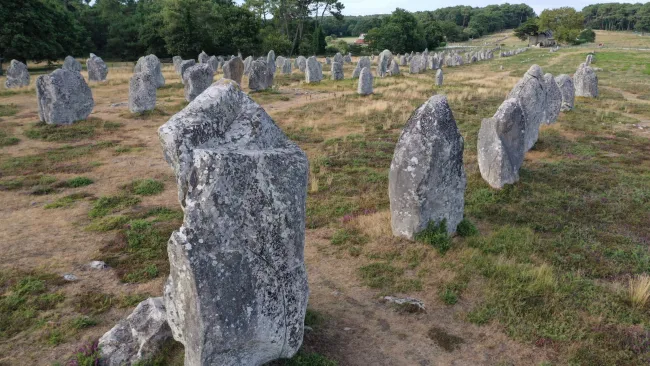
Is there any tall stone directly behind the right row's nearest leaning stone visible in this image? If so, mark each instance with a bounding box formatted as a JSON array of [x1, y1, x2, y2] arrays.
[[508, 65, 546, 151]]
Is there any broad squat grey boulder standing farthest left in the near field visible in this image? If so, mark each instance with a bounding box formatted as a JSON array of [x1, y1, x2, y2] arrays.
[[36, 69, 95, 125]]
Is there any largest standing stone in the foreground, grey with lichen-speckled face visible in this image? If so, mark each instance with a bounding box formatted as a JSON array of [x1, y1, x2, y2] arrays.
[[158, 80, 309, 366]]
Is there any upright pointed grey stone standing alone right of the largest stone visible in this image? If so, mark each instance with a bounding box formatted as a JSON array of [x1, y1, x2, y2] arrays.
[[388, 95, 467, 239]]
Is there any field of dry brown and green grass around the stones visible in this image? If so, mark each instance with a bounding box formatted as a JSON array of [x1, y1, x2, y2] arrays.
[[0, 32, 650, 365]]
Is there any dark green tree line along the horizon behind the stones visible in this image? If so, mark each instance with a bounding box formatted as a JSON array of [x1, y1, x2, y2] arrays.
[[0, 0, 650, 61]]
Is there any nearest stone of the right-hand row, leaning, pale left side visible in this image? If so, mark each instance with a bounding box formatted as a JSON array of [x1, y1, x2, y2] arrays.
[[477, 98, 526, 189]]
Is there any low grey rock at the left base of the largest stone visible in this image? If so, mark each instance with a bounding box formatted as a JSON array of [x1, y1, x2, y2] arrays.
[[99, 297, 172, 366]]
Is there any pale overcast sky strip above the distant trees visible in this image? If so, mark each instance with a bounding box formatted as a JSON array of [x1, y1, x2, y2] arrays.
[[341, 0, 616, 15]]
